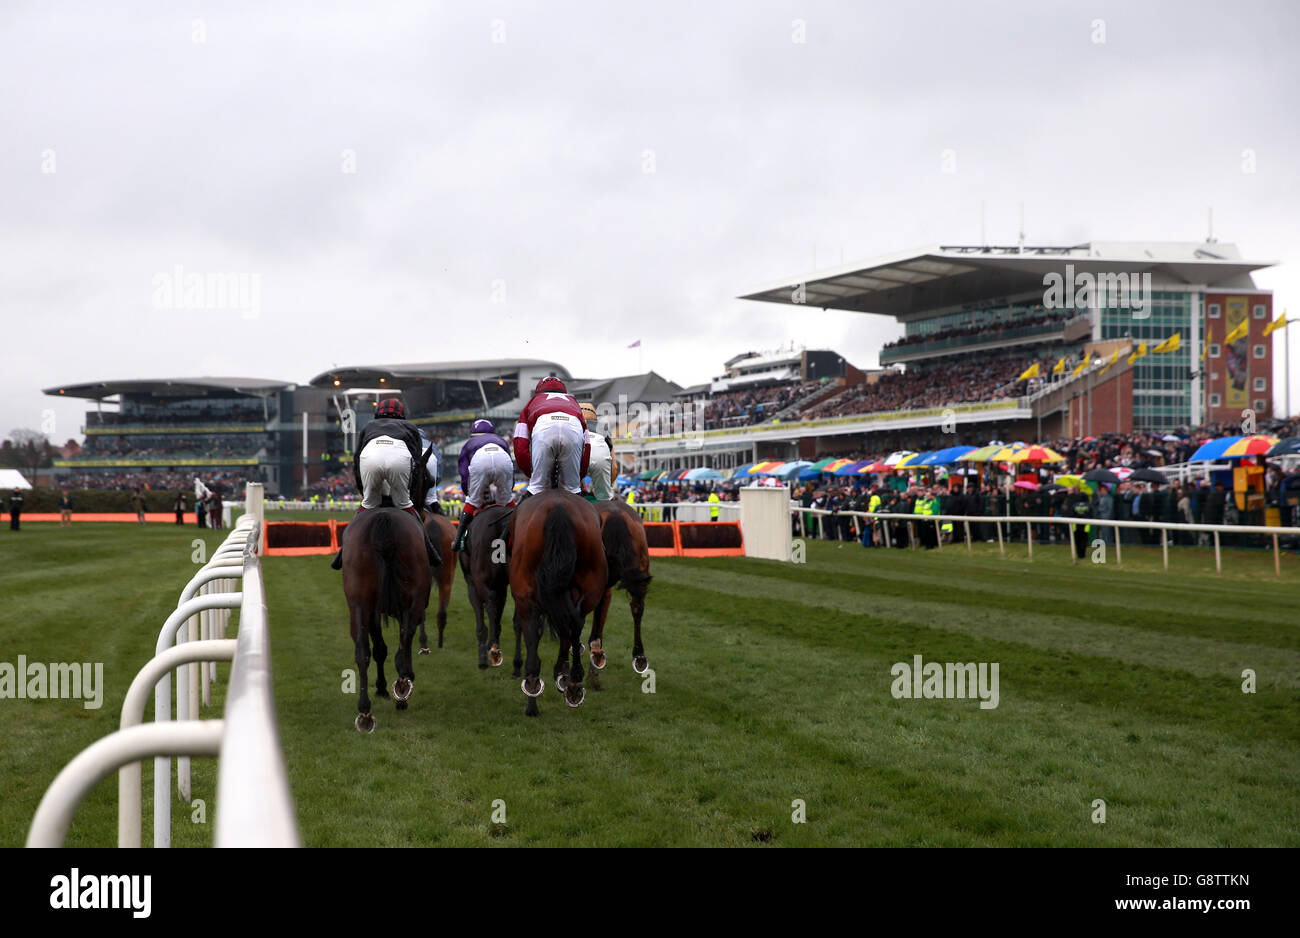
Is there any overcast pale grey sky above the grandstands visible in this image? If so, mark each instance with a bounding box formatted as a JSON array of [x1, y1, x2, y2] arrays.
[[0, 0, 1300, 442]]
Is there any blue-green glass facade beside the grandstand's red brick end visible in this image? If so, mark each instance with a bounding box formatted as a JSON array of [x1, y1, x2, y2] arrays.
[[1101, 290, 1192, 431]]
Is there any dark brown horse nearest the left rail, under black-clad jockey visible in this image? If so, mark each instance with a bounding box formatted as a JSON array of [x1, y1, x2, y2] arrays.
[[343, 450, 434, 733]]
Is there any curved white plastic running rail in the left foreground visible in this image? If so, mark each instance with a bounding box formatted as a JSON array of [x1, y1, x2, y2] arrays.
[[27, 483, 299, 847]]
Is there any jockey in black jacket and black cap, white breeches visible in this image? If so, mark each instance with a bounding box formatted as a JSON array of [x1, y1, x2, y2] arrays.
[[330, 398, 442, 570]]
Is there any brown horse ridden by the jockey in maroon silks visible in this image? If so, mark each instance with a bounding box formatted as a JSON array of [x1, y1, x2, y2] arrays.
[[510, 488, 607, 717]]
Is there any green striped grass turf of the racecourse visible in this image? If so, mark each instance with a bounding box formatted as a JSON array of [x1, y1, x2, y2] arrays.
[[0, 524, 1300, 846]]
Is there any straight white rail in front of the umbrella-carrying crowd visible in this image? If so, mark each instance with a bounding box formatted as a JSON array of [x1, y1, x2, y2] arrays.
[[790, 501, 1300, 578]]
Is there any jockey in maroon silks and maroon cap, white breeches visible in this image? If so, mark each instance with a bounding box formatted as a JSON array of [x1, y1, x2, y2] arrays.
[[515, 375, 592, 498]]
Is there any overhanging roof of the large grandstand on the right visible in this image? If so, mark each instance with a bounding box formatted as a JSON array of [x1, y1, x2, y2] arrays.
[[740, 242, 1277, 320]]
